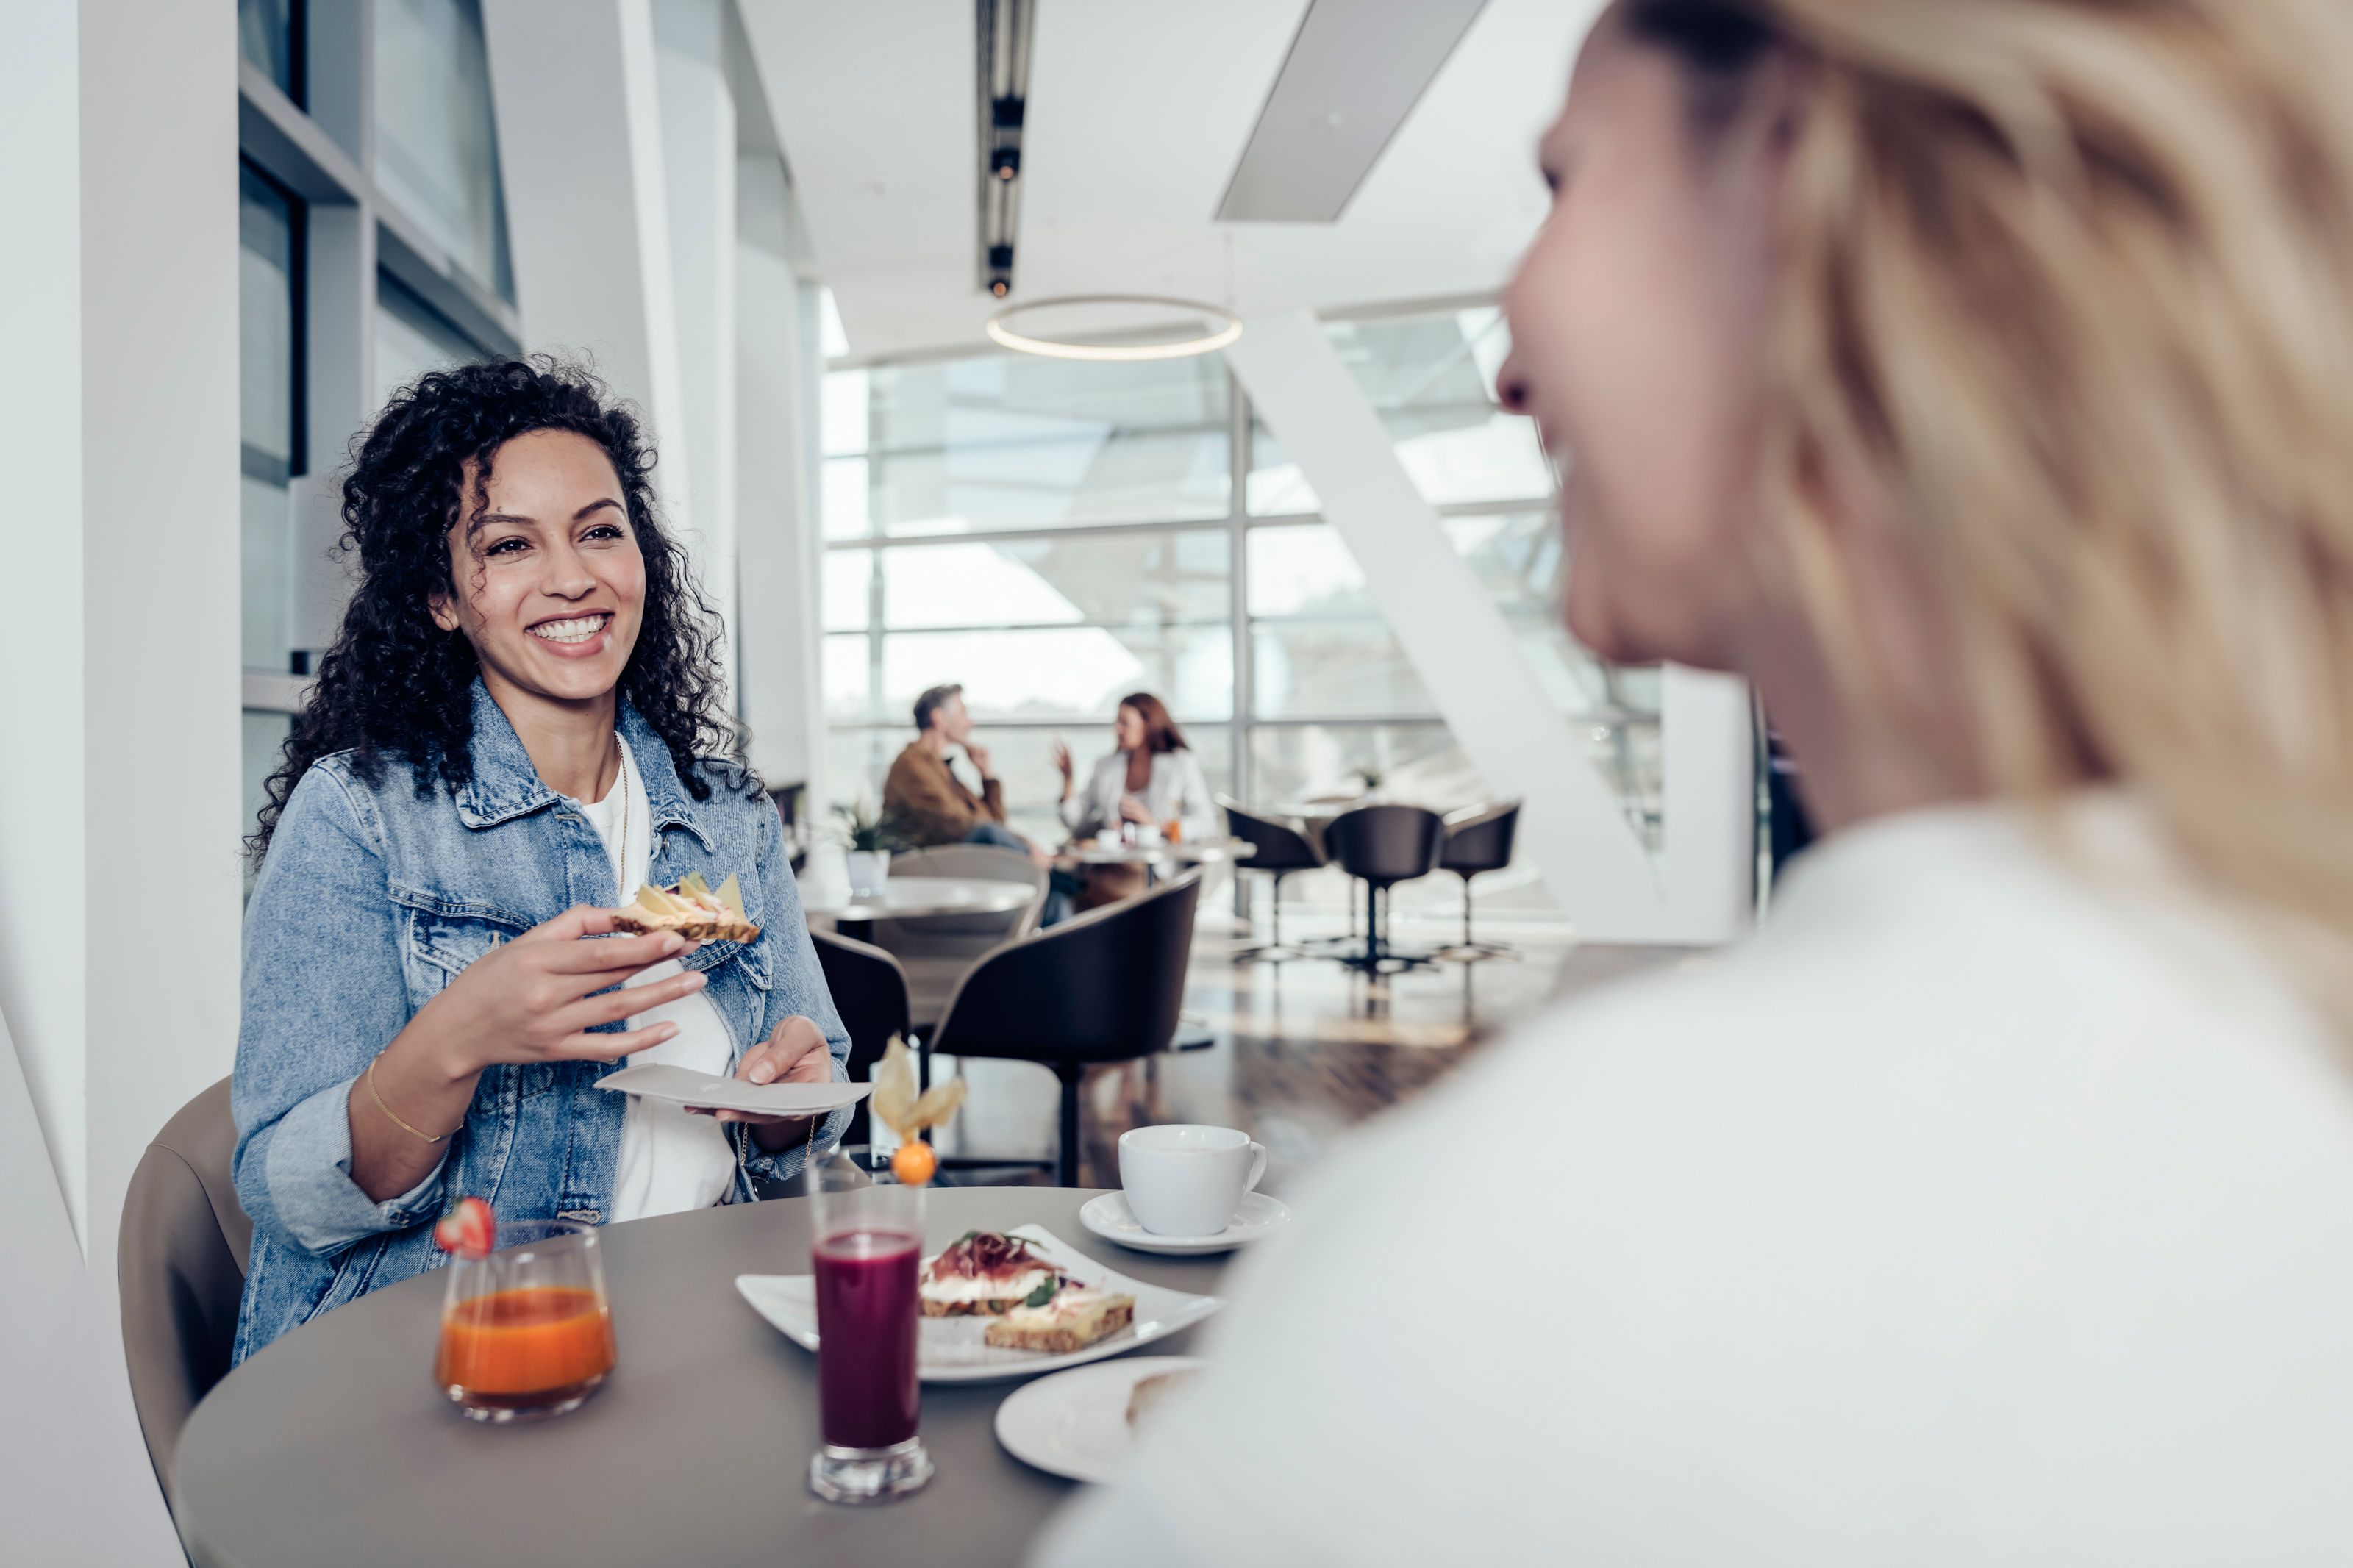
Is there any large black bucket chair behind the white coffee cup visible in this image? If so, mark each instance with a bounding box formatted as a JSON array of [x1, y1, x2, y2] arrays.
[[925, 870, 1200, 1187]]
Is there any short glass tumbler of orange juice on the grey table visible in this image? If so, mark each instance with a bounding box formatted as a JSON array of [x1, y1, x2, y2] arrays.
[[433, 1220, 614, 1422]]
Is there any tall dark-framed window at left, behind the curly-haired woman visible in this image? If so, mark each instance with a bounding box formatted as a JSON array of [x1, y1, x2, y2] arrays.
[[238, 0, 518, 870]]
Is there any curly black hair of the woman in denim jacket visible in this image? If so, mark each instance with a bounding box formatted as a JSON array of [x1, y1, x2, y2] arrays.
[[247, 355, 749, 863]]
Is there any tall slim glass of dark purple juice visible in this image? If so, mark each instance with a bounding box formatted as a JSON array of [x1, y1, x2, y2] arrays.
[[810, 1154, 932, 1502]]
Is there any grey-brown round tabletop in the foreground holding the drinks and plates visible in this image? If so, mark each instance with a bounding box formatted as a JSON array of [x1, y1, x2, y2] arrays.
[[174, 1187, 1226, 1568]]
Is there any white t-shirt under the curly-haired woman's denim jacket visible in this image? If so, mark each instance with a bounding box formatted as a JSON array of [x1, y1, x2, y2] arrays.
[[567, 740, 737, 1222]]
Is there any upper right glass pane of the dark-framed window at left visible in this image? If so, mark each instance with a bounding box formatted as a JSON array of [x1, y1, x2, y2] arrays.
[[374, 0, 515, 298]]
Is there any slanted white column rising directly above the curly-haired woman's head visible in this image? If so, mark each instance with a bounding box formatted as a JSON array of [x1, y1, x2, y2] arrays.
[[482, 0, 694, 517]]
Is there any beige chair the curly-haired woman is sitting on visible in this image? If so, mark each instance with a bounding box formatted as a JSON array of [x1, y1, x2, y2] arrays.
[[115, 1079, 254, 1502]]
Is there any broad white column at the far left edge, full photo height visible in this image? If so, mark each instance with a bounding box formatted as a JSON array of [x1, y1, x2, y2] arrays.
[[0, 0, 243, 1566]]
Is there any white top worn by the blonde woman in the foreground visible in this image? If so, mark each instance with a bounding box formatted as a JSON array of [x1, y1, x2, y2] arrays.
[[1033, 799, 2353, 1568]]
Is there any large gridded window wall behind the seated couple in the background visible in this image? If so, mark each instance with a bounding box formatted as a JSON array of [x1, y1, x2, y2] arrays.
[[821, 308, 1661, 907]]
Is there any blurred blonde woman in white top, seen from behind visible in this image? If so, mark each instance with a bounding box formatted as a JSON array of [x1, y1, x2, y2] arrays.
[[1043, 0, 2353, 1568]]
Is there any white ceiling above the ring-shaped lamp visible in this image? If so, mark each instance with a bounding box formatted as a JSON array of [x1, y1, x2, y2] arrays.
[[739, 0, 1602, 357]]
